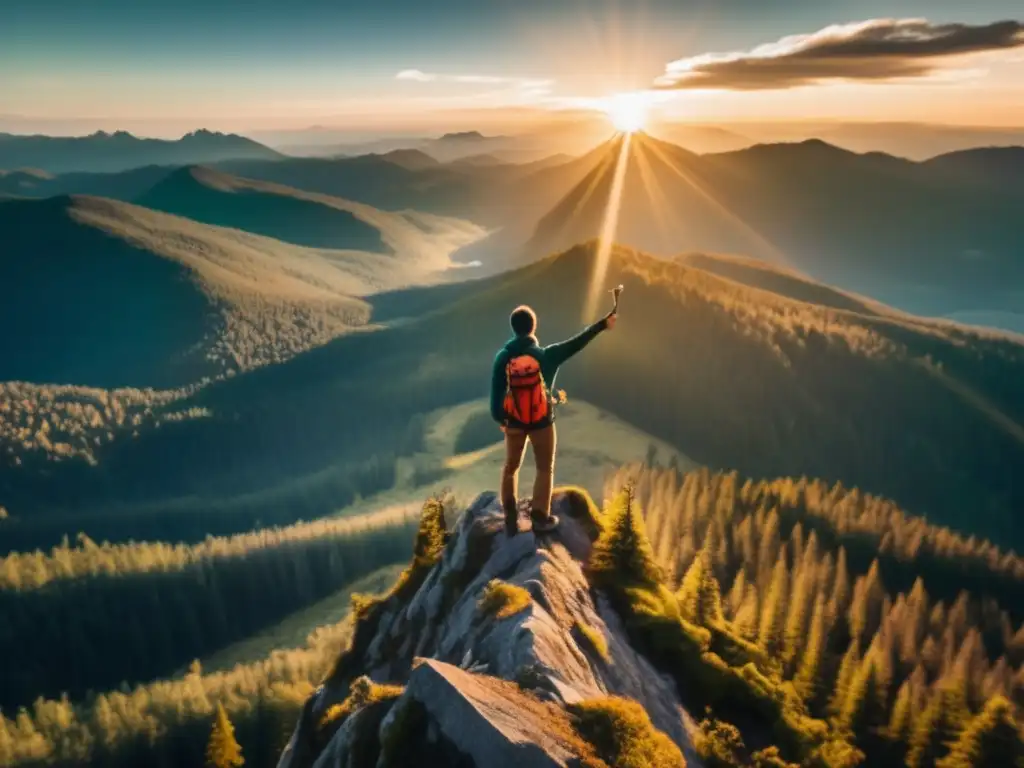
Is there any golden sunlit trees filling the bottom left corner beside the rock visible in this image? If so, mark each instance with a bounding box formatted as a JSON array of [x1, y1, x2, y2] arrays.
[[0, 585, 351, 768]]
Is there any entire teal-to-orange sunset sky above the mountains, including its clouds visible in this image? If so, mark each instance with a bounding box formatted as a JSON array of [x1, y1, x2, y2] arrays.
[[0, 0, 1024, 135]]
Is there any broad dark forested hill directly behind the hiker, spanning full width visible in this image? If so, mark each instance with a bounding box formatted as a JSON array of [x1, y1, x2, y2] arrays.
[[0, 246, 1024, 547]]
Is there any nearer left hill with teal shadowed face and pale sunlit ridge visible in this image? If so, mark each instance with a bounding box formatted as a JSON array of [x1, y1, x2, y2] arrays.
[[0, 198, 369, 386]]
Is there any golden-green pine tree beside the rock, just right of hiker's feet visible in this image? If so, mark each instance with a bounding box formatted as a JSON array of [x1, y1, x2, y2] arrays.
[[590, 485, 662, 589]]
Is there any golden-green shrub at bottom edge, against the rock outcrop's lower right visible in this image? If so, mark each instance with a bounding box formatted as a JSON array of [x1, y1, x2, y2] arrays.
[[567, 696, 686, 768]]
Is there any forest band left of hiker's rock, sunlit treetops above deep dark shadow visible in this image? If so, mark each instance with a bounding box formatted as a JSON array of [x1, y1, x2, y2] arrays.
[[0, 509, 415, 710]]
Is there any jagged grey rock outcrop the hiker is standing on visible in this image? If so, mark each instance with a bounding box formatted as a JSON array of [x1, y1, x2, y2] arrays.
[[279, 492, 699, 768]]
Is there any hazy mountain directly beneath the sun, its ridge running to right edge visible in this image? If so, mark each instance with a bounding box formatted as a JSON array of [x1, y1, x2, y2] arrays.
[[524, 134, 1024, 314]]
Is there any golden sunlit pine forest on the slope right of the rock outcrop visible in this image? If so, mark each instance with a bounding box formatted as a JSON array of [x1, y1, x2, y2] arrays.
[[609, 467, 1024, 768]]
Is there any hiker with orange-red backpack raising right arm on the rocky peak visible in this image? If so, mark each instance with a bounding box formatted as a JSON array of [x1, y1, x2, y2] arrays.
[[490, 303, 621, 536]]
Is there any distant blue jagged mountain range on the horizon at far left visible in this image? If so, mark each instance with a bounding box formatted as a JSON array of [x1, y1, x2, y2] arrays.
[[0, 130, 283, 173]]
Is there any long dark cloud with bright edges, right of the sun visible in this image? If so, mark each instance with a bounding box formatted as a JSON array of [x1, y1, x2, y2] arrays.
[[654, 18, 1024, 90]]
